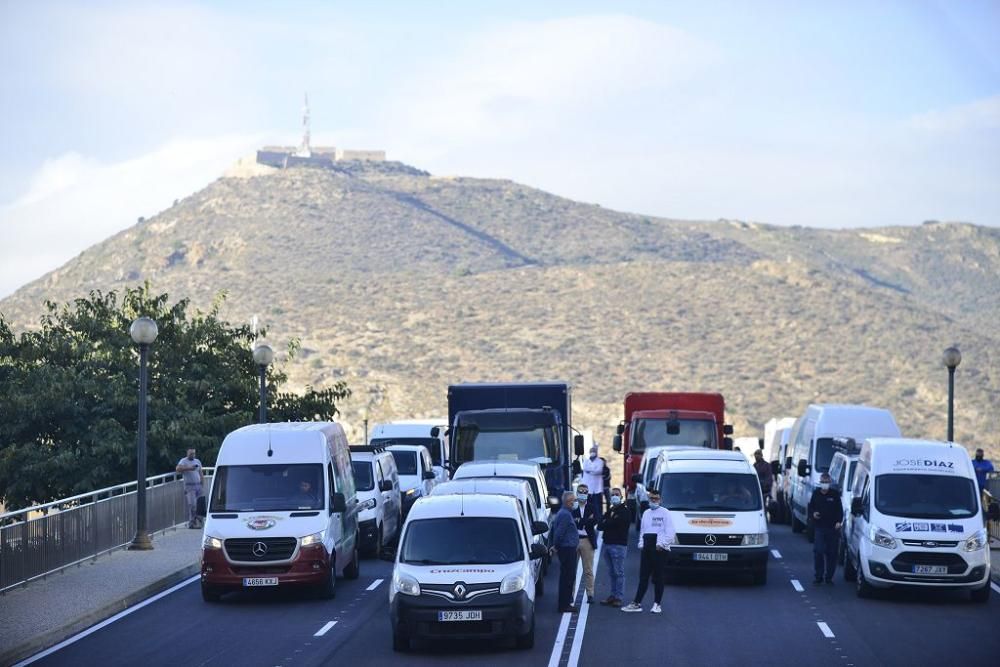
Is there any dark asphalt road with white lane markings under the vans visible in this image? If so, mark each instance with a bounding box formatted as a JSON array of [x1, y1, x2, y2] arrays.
[[23, 526, 1000, 667]]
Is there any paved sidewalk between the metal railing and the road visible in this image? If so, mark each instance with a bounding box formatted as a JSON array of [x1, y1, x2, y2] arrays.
[[0, 525, 202, 665]]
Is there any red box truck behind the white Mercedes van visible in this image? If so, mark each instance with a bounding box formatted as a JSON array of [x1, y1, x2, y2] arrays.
[[613, 392, 733, 495]]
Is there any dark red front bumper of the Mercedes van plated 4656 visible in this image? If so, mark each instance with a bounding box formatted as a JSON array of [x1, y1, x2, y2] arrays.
[[201, 544, 333, 589]]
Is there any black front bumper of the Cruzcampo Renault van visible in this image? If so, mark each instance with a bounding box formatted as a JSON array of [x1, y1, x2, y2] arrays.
[[389, 591, 535, 639]]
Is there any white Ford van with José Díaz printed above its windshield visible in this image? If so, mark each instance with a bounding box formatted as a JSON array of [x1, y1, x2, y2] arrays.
[[844, 438, 1000, 602]]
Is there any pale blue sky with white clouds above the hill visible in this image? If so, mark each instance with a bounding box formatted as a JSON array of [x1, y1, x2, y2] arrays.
[[0, 0, 1000, 297]]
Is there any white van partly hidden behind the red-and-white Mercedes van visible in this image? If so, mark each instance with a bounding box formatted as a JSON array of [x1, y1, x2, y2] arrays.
[[351, 445, 403, 556]]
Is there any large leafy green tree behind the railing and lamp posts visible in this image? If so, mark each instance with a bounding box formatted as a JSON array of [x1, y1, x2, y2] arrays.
[[0, 285, 350, 508]]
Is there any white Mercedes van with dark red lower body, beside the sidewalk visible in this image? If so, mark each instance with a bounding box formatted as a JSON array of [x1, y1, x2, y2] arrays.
[[201, 422, 359, 602]]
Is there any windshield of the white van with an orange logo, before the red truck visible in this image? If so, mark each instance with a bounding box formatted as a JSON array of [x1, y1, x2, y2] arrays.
[[660, 472, 761, 512]]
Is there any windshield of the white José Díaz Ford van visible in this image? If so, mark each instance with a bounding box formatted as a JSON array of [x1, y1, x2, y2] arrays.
[[875, 475, 979, 519]]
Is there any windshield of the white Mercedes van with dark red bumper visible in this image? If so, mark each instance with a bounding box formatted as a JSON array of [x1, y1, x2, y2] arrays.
[[209, 463, 325, 512]]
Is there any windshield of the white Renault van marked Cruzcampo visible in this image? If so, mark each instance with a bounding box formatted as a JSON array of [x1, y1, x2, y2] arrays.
[[400, 517, 524, 565]]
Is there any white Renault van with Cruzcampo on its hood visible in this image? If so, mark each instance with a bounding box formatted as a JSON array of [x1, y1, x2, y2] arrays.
[[389, 494, 548, 651]]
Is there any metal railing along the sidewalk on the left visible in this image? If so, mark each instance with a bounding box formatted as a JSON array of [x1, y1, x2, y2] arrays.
[[0, 468, 213, 593]]
